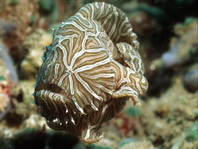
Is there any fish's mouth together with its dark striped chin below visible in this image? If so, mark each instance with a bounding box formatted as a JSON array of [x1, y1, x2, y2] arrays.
[[33, 83, 69, 121]]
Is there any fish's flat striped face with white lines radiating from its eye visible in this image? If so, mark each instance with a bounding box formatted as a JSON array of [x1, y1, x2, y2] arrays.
[[34, 23, 115, 114]]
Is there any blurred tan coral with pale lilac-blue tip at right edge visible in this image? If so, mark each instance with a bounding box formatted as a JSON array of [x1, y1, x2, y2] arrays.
[[162, 18, 198, 67]]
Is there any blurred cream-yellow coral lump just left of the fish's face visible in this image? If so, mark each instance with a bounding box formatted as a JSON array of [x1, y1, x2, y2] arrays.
[[19, 29, 52, 79]]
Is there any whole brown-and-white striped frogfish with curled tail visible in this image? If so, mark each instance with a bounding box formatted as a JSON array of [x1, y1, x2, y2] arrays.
[[34, 3, 148, 143]]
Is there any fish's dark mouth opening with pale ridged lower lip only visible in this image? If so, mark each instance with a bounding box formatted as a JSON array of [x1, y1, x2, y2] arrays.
[[33, 83, 67, 105]]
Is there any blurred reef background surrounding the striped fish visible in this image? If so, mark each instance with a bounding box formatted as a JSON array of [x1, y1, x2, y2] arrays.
[[0, 0, 198, 149]]
